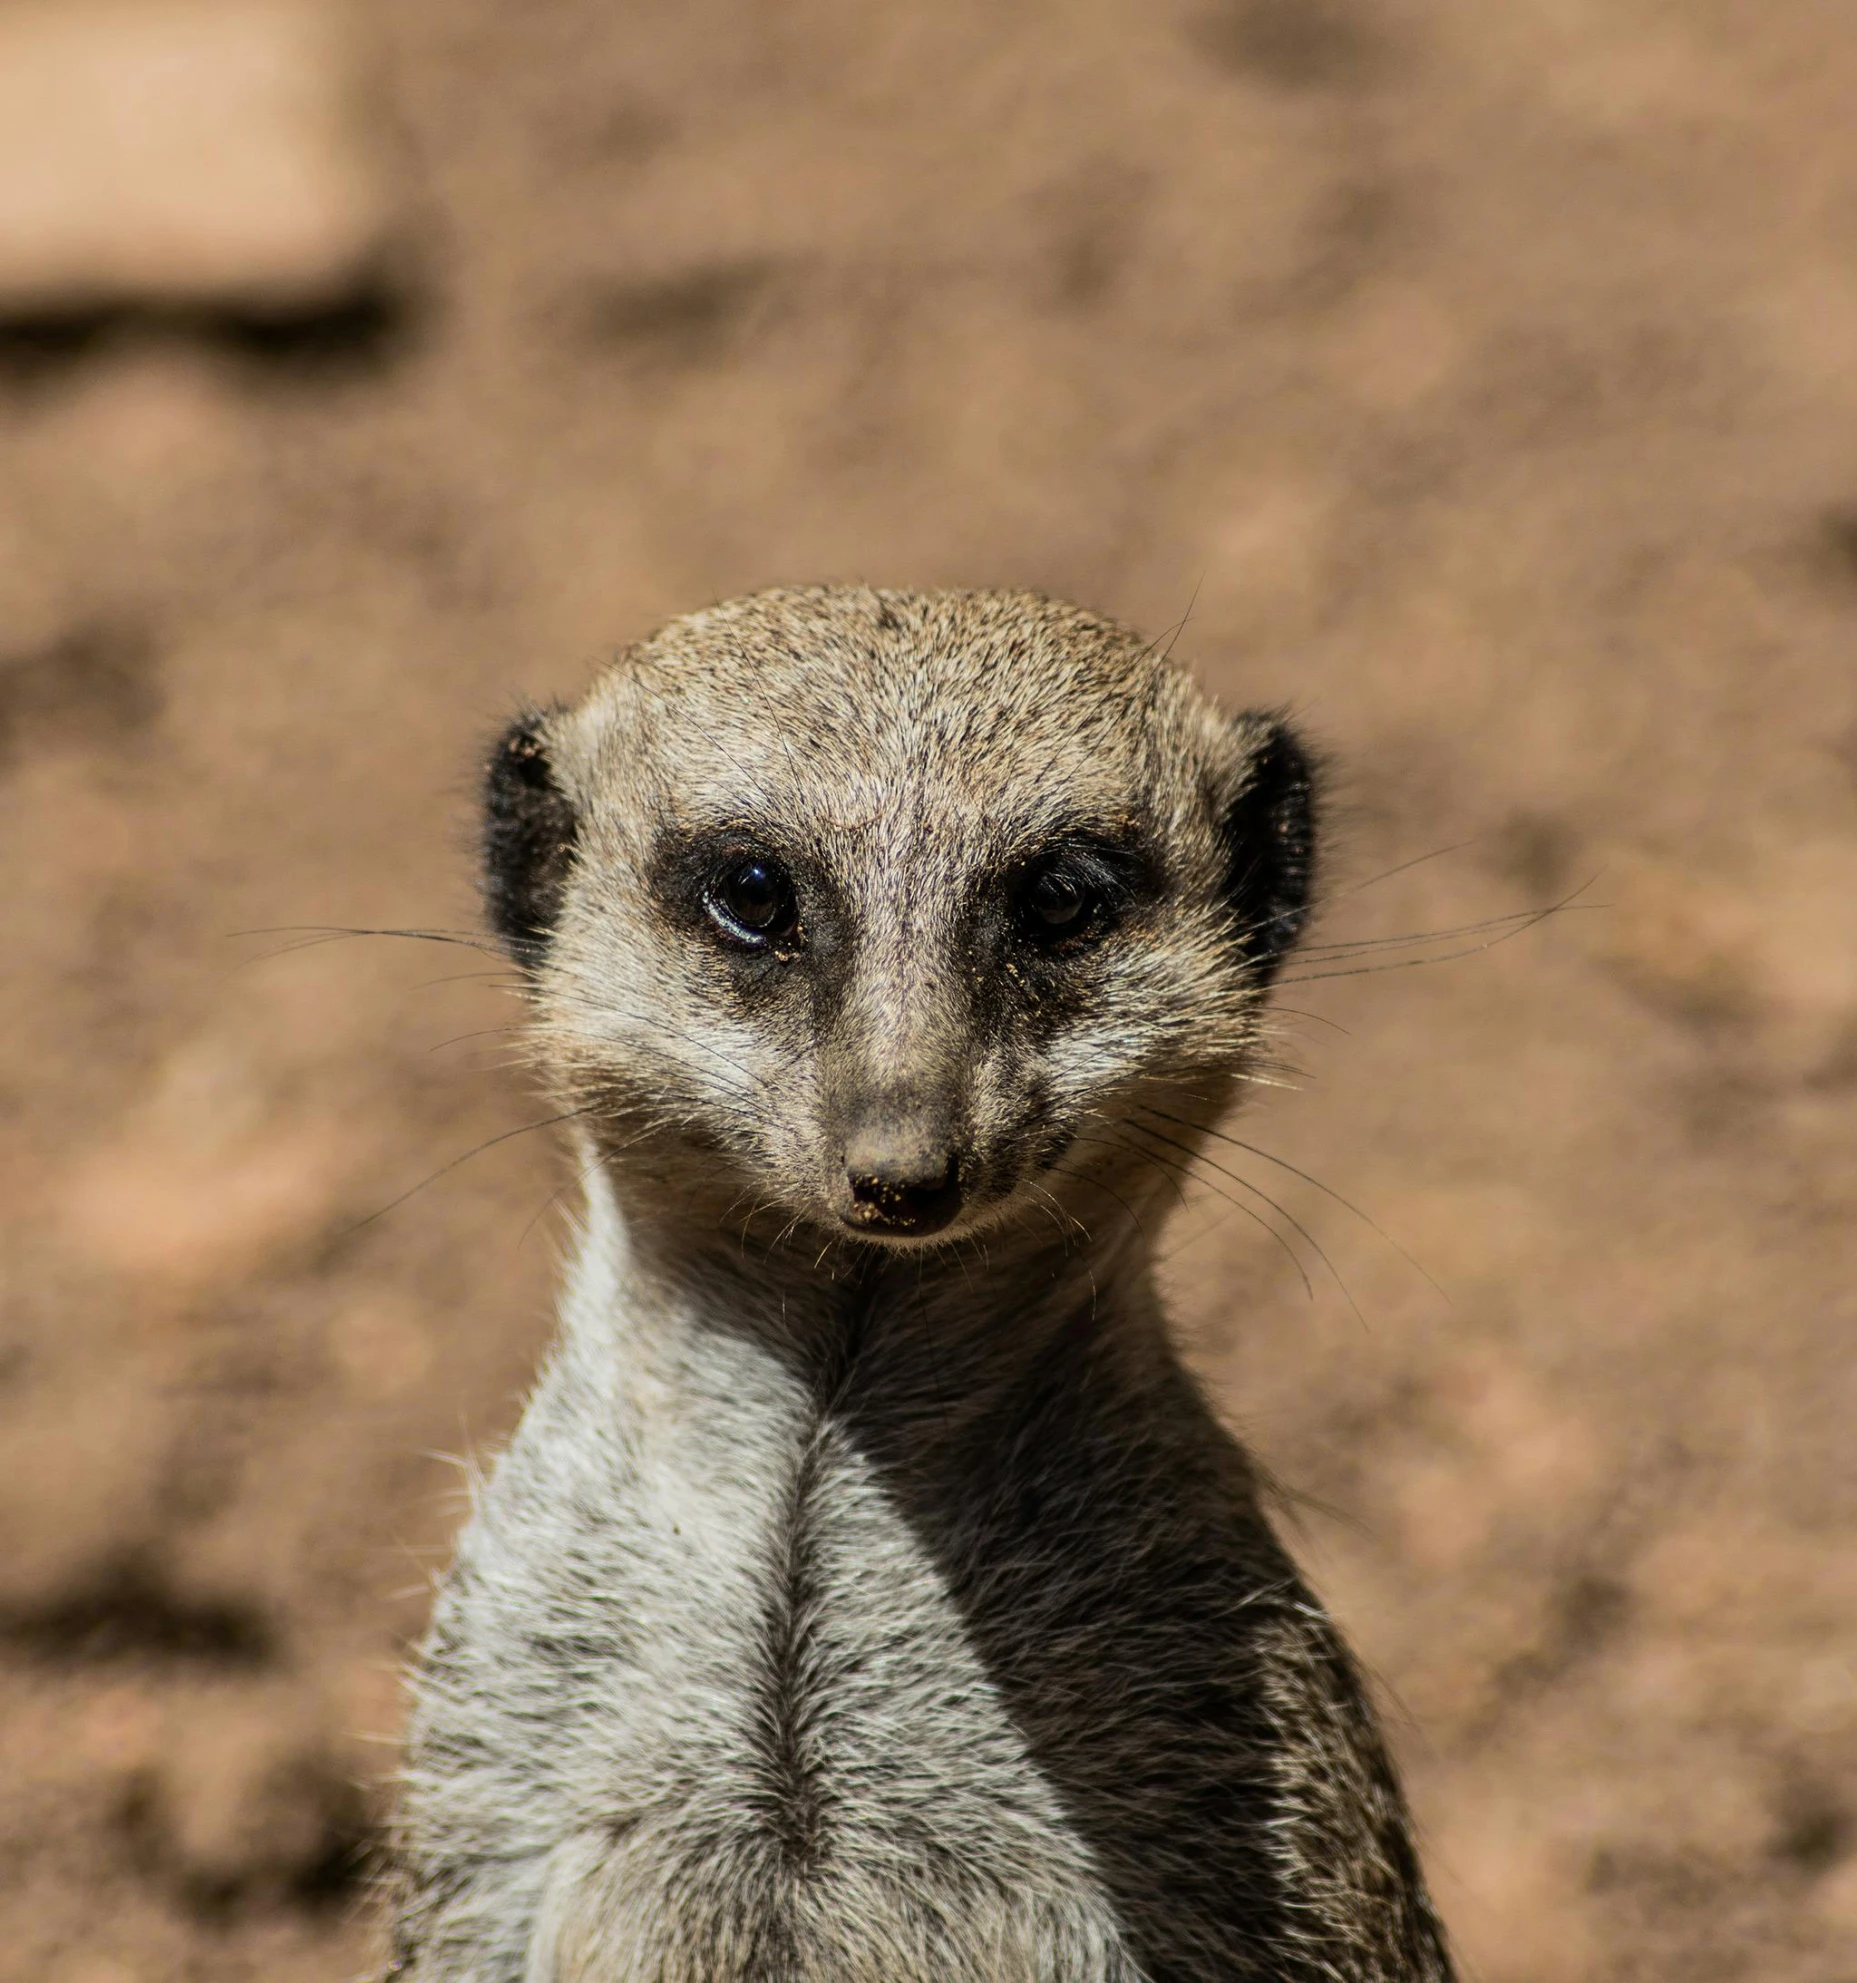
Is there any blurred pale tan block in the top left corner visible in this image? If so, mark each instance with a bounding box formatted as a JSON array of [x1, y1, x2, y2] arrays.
[[0, 0, 389, 317]]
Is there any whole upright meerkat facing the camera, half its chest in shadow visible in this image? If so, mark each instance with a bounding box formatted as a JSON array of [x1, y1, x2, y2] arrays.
[[391, 589, 1450, 1983]]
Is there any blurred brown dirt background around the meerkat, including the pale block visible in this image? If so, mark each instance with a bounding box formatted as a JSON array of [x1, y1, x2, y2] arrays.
[[0, 0, 1857, 1983]]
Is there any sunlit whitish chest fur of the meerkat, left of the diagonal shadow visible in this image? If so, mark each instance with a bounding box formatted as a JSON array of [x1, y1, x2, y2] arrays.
[[400, 1221, 1137, 1983]]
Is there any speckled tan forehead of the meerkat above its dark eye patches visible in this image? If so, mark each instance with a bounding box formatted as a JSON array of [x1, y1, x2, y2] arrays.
[[559, 587, 1218, 841]]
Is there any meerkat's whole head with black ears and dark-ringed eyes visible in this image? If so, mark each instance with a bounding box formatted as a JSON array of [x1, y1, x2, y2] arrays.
[[486, 589, 1313, 1245]]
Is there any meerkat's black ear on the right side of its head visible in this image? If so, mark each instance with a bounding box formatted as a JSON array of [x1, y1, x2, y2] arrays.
[[1220, 716, 1315, 984]]
